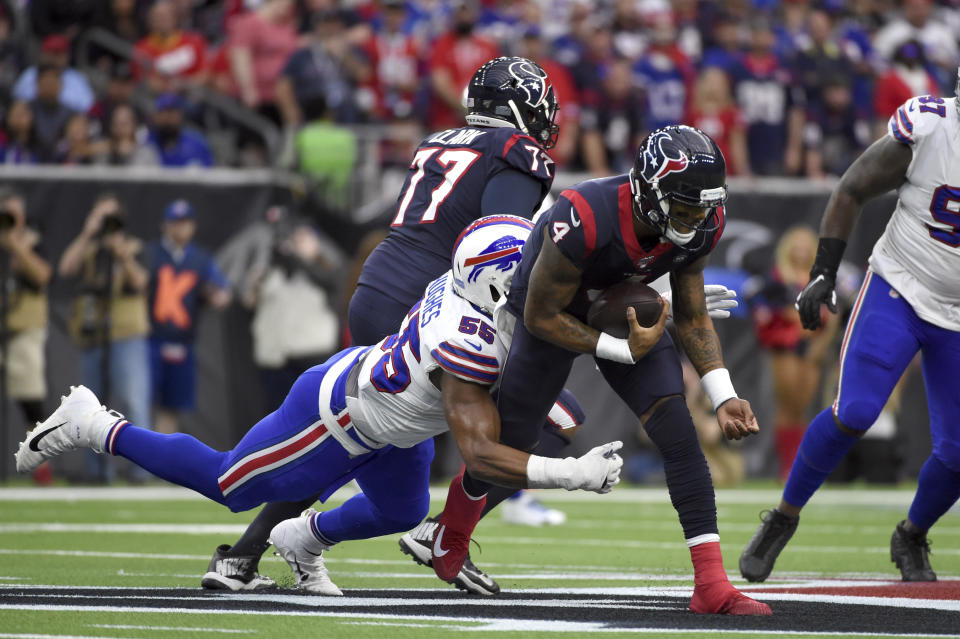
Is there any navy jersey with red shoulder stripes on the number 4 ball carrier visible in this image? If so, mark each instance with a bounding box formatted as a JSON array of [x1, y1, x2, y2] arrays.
[[508, 175, 724, 320]]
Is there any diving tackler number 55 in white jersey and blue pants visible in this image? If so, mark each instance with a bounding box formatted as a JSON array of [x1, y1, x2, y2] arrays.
[[16, 215, 623, 595]]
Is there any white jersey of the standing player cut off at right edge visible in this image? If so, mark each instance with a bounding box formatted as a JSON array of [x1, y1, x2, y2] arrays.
[[870, 96, 960, 331]]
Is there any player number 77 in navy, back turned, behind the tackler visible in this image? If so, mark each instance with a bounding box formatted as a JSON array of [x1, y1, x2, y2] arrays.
[[198, 57, 583, 594]]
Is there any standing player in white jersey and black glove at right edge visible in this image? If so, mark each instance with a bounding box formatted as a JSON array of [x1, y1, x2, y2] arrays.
[[740, 76, 960, 581]]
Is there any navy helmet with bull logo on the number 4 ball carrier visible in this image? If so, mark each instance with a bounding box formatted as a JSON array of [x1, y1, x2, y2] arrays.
[[630, 125, 727, 247]]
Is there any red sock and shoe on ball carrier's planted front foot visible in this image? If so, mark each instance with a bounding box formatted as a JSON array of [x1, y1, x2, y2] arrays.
[[690, 541, 773, 615]]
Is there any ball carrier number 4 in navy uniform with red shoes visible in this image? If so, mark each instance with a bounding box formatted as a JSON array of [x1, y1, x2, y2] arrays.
[[420, 126, 771, 615]]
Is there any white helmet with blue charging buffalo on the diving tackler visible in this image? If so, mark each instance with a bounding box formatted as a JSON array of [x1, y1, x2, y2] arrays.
[[453, 215, 533, 315]]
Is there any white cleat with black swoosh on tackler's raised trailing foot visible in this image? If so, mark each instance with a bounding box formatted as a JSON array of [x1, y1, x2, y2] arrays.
[[15, 386, 123, 473]]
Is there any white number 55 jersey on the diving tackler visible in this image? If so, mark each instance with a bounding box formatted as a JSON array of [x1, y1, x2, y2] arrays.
[[350, 272, 506, 448]]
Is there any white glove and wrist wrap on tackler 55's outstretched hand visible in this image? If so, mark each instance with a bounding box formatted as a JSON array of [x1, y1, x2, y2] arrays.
[[527, 441, 623, 494]]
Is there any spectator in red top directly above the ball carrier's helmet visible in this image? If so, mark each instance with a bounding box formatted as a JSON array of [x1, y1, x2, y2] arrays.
[[688, 67, 750, 175]]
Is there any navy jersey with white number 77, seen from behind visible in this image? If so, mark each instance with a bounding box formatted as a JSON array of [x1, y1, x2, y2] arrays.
[[359, 127, 554, 306]]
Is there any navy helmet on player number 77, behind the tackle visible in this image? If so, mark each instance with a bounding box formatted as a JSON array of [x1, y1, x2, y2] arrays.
[[467, 57, 560, 149]]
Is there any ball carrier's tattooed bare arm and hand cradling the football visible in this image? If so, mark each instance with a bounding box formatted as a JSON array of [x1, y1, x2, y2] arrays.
[[523, 229, 668, 359]]
